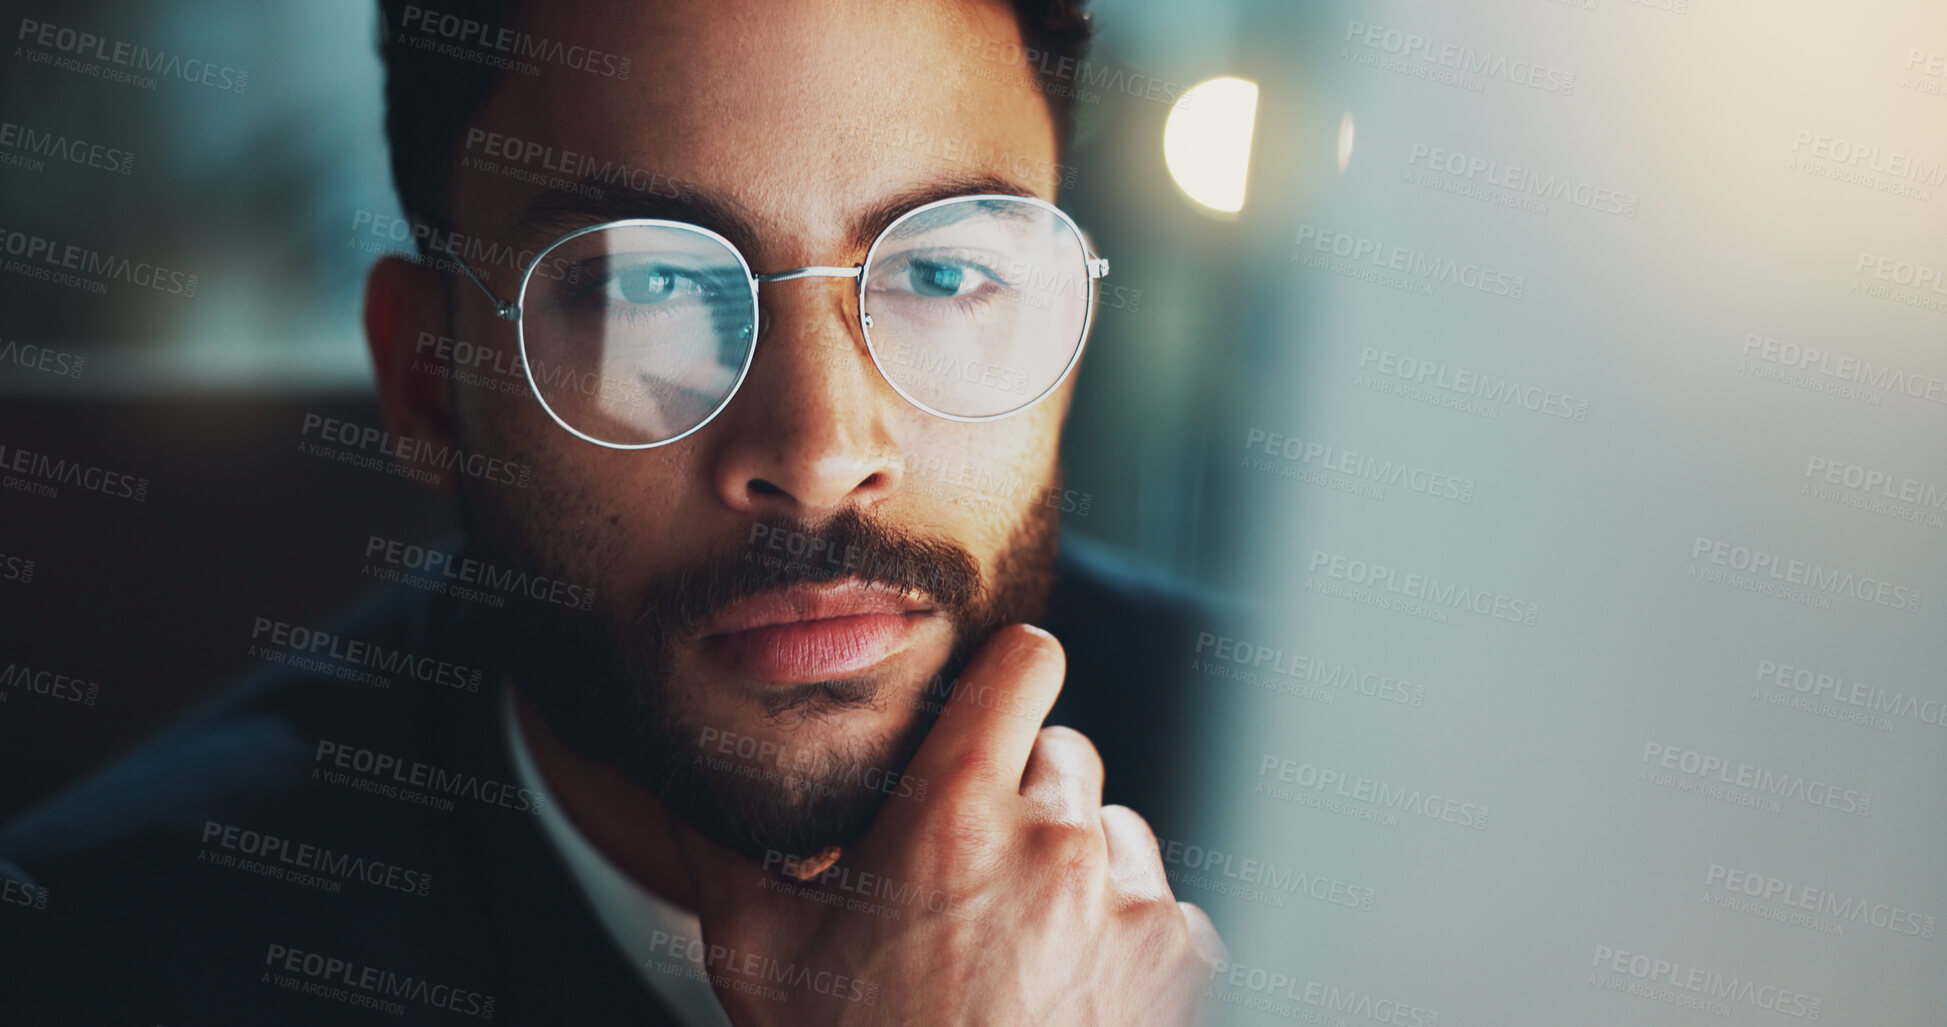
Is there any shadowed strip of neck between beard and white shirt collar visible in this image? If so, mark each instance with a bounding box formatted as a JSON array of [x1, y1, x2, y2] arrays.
[[514, 688, 697, 910]]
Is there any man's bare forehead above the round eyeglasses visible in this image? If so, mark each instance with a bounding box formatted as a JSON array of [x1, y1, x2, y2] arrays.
[[454, 0, 1057, 263]]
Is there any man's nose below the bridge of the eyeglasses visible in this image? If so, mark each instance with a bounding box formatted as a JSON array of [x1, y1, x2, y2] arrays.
[[711, 269, 903, 518]]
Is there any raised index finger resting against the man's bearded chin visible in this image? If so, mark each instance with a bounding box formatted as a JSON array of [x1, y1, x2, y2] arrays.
[[907, 624, 1067, 801]]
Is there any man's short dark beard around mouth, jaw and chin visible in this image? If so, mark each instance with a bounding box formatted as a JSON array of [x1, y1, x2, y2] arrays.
[[458, 483, 1059, 859]]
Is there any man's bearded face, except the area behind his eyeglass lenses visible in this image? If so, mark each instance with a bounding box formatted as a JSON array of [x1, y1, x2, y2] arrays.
[[432, 0, 1073, 854]]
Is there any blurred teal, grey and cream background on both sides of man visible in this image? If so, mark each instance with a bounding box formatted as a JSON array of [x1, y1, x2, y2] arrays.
[[0, 0, 1947, 1027]]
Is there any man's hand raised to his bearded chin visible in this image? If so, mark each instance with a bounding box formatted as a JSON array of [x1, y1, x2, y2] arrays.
[[665, 626, 1223, 1027]]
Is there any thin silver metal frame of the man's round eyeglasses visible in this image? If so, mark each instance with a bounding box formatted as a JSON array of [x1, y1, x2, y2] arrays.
[[440, 193, 1108, 450]]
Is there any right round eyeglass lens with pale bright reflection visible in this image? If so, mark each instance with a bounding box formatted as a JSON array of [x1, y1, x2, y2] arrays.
[[864, 197, 1090, 417]]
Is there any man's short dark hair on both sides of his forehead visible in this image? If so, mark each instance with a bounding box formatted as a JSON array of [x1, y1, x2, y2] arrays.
[[378, 0, 1092, 249]]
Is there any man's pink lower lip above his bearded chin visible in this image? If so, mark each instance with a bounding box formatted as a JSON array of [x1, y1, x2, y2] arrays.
[[703, 612, 927, 684]]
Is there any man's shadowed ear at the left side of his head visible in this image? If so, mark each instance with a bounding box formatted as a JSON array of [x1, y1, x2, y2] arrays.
[[364, 257, 456, 493]]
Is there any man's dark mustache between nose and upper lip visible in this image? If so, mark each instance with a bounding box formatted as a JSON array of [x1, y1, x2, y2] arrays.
[[637, 507, 987, 637]]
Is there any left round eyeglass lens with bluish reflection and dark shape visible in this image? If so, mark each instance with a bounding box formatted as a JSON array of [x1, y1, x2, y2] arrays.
[[520, 224, 757, 446]]
